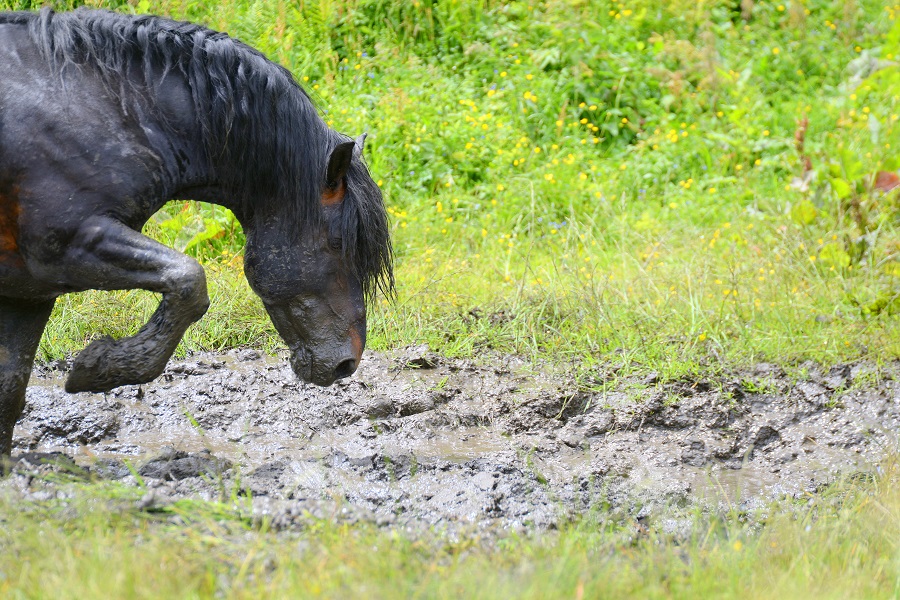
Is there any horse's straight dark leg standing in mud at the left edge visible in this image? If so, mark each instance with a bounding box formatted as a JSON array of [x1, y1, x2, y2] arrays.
[[0, 298, 53, 460]]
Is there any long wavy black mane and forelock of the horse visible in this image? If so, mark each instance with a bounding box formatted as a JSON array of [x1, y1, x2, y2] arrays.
[[0, 8, 393, 297]]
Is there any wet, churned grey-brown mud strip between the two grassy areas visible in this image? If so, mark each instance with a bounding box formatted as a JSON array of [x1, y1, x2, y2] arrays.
[[7, 348, 900, 531]]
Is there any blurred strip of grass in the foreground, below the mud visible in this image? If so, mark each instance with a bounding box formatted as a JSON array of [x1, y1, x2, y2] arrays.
[[0, 464, 900, 598]]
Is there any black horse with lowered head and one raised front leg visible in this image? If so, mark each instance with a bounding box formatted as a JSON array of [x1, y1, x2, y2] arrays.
[[0, 9, 393, 457]]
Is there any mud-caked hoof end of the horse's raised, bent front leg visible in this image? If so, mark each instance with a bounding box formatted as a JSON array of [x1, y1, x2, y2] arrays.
[[66, 337, 166, 393]]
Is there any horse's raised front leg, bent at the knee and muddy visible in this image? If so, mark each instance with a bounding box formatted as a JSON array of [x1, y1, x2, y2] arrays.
[[57, 217, 209, 392]]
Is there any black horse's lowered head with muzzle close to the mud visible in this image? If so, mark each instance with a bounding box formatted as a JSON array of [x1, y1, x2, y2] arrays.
[[244, 135, 393, 386]]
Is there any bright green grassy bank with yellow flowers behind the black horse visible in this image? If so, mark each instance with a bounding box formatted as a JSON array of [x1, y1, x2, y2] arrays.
[[7, 0, 900, 377]]
